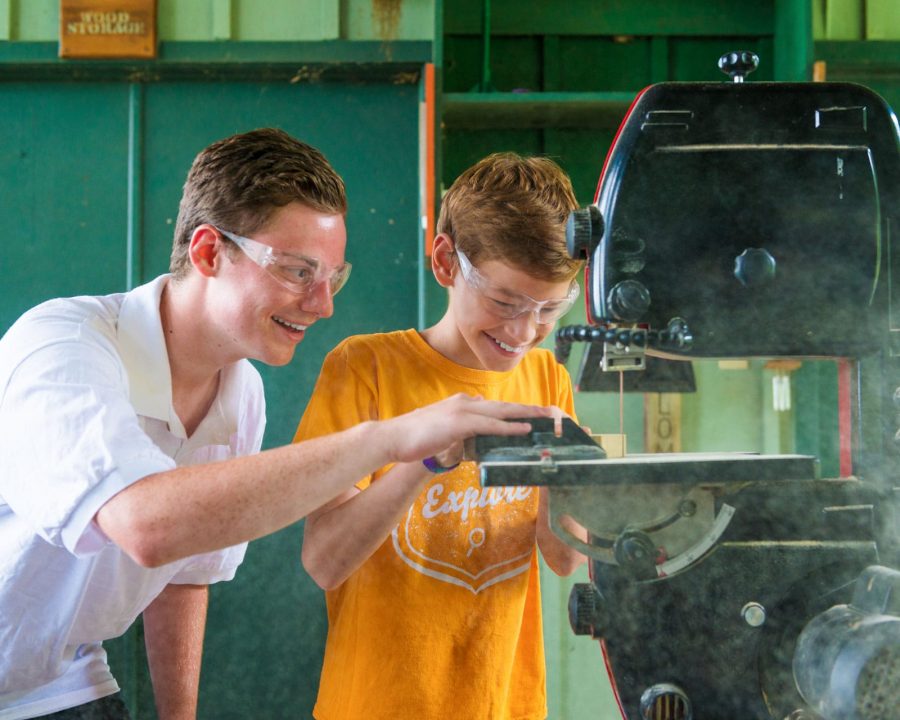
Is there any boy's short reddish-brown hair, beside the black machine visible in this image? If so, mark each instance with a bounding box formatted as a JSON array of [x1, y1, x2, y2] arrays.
[[437, 152, 582, 281]]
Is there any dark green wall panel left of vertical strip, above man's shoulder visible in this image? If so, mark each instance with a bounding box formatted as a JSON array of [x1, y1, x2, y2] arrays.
[[0, 83, 128, 332]]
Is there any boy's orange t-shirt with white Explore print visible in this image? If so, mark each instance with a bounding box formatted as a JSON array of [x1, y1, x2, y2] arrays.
[[295, 330, 574, 720]]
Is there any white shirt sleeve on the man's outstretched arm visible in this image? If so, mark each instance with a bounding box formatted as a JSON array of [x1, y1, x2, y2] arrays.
[[0, 338, 175, 555]]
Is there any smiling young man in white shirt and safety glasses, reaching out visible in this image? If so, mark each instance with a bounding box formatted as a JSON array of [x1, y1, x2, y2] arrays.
[[0, 129, 550, 720]]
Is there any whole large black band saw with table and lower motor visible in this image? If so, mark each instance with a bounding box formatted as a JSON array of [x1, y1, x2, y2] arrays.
[[482, 53, 900, 720]]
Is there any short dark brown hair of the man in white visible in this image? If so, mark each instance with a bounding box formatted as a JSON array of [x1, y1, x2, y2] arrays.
[[169, 128, 347, 279]]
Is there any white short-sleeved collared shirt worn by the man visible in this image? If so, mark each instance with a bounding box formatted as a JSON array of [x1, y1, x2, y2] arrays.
[[0, 276, 265, 720]]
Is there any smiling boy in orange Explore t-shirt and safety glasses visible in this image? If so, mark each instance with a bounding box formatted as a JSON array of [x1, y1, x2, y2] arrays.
[[295, 153, 584, 720]]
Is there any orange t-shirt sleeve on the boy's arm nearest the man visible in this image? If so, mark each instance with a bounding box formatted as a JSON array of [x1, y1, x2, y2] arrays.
[[294, 340, 378, 489]]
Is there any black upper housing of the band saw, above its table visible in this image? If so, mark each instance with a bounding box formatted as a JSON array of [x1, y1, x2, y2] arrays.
[[586, 83, 900, 357]]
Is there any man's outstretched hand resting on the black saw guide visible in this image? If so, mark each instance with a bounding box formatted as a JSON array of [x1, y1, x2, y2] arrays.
[[380, 393, 553, 466]]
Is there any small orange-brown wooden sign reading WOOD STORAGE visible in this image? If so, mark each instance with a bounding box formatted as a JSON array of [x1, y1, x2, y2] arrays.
[[59, 0, 156, 58]]
